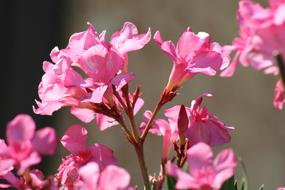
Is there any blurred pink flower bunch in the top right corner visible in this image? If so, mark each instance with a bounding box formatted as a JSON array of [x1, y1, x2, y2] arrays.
[[222, 0, 285, 76]]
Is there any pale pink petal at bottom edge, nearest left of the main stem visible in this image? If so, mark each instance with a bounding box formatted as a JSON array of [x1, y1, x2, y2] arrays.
[[98, 165, 131, 190]]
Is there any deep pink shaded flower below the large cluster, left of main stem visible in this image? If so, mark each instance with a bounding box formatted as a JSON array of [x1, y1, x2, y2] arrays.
[[56, 125, 117, 187]]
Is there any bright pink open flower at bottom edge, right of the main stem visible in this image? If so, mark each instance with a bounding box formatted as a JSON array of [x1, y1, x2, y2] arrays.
[[167, 143, 237, 190]]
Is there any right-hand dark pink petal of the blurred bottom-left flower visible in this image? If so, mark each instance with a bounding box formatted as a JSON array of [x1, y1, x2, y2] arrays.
[[32, 127, 57, 155]]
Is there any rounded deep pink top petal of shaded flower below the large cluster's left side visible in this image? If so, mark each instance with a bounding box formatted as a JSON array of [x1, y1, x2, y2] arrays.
[[60, 125, 88, 153]]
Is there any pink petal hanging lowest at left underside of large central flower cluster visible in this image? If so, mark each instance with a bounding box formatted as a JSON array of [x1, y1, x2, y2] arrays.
[[70, 107, 96, 123]]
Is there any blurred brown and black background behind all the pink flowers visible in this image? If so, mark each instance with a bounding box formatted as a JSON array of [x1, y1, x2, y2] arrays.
[[0, 0, 285, 189]]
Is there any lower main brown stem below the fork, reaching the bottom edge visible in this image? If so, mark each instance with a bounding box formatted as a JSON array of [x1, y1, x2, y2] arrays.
[[134, 143, 151, 190]]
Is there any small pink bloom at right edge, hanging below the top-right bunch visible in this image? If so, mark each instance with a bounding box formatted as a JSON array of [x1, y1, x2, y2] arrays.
[[273, 80, 285, 110]]
